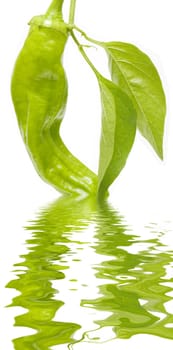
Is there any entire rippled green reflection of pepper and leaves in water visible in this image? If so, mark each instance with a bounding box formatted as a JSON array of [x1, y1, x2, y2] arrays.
[[7, 197, 173, 350]]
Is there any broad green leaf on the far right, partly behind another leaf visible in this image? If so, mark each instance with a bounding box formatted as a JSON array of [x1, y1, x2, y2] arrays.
[[102, 42, 166, 159]]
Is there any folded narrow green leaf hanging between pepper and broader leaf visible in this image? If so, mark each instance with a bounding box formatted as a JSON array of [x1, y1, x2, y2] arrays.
[[97, 75, 136, 198]]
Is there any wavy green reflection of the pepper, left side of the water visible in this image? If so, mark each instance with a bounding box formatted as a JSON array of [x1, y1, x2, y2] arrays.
[[7, 198, 95, 350]]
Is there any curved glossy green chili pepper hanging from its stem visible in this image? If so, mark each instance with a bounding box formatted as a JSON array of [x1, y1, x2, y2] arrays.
[[11, 0, 97, 194]]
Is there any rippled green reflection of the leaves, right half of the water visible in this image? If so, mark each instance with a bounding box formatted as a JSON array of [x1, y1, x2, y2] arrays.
[[81, 203, 173, 339]]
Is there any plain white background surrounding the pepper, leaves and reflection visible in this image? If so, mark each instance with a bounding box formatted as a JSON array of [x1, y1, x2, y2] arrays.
[[0, 0, 173, 350]]
